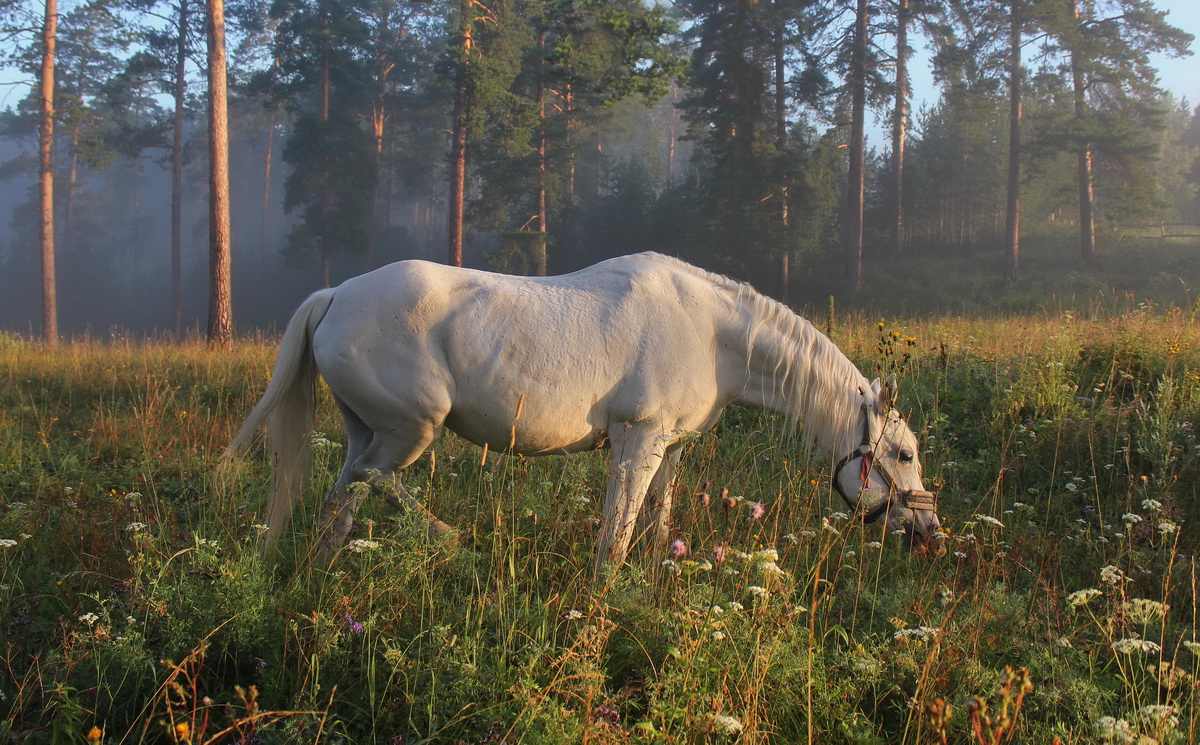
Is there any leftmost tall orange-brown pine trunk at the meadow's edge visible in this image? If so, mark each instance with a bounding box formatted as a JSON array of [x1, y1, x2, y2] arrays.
[[37, 0, 59, 346]]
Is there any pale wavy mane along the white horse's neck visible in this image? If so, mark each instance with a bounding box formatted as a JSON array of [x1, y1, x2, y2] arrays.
[[654, 254, 868, 453]]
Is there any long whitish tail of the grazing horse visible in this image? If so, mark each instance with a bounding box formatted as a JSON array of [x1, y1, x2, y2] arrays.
[[223, 289, 336, 549]]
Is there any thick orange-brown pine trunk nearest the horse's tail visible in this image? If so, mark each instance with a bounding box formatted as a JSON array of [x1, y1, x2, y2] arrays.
[[208, 0, 233, 347]]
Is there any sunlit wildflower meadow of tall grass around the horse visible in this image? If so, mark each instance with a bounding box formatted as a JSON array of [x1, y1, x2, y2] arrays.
[[0, 304, 1200, 744]]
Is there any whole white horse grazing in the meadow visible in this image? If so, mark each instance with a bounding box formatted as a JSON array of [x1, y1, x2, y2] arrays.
[[227, 253, 938, 569]]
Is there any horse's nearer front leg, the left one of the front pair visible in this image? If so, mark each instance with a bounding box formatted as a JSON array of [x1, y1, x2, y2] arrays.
[[595, 422, 674, 576]]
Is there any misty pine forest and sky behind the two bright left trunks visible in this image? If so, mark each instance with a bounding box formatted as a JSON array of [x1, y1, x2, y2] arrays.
[[0, 0, 1200, 336]]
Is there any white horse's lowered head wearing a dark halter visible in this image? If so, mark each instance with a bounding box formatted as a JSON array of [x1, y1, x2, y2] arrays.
[[833, 377, 946, 555]]
